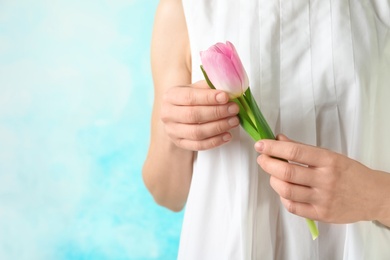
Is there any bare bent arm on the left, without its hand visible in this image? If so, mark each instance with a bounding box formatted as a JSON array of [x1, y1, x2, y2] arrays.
[[143, 0, 194, 211]]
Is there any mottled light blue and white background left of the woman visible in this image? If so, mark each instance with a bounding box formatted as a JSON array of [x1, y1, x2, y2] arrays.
[[0, 0, 182, 260]]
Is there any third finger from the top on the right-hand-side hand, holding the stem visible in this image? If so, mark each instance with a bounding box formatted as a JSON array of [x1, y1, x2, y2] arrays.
[[270, 176, 313, 203]]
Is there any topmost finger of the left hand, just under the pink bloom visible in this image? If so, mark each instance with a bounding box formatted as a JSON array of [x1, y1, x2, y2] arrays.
[[163, 87, 229, 106]]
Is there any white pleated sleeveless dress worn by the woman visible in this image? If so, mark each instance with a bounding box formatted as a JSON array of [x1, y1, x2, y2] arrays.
[[179, 0, 390, 260]]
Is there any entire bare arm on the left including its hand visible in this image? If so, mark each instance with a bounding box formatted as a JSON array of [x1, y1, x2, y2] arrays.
[[143, 0, 239, 211]]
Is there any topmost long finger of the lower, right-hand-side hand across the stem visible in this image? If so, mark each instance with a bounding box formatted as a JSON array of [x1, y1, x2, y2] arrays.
[[255, 140, 332, 166]]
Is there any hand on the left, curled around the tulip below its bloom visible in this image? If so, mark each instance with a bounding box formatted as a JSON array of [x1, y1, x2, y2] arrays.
[[161, 81, 239, 151]]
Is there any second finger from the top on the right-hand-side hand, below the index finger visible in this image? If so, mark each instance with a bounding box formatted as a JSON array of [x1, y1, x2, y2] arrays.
[[257, 154, 318, 187]]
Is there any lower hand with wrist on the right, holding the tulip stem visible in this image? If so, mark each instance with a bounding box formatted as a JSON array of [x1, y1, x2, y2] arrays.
[[255, 135, 390, 225]]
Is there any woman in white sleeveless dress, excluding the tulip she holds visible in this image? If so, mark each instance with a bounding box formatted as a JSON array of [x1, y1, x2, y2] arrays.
[[143, 0, 390, 259]]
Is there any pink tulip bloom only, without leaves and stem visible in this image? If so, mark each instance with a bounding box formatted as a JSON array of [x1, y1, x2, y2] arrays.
[[200, 42, 249, 99]]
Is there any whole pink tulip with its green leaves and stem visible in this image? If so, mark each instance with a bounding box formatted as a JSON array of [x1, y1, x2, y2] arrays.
[[200, 42, 319, 240]]
